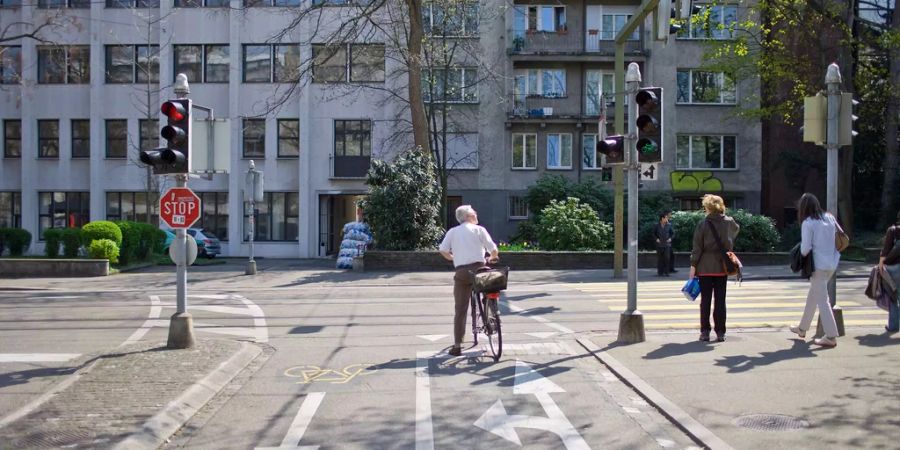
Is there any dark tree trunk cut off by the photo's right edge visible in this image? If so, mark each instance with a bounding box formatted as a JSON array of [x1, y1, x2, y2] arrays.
[[881, 7, 900, 228]]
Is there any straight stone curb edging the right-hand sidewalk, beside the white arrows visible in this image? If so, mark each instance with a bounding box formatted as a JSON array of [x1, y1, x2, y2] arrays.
[[576, 338, 733, 450]]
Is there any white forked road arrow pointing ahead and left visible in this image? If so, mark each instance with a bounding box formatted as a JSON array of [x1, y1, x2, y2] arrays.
[[475, 361, 591, 450]]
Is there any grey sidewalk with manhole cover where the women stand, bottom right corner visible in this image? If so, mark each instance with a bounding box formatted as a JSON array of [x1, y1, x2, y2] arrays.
[[581, 326, 900, 449]]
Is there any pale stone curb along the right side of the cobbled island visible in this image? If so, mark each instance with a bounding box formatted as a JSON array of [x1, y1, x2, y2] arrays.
[[113, 342, 262, 450]]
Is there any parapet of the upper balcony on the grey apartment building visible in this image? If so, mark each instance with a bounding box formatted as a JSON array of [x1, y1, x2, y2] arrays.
[[507, 29, 644, 56]]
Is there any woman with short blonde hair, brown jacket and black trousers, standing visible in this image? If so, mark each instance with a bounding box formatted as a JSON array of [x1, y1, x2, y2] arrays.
[[688, 194, 741, 342]]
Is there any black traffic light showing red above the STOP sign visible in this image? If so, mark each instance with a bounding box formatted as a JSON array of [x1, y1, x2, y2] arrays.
[[140, 99, 191, 175]]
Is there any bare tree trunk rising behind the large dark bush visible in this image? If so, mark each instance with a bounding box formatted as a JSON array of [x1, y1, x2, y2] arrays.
[[406, 0, 431, 155]]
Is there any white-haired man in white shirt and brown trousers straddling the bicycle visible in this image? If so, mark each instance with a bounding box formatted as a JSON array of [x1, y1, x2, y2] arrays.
[[439, 205, 500, 356]]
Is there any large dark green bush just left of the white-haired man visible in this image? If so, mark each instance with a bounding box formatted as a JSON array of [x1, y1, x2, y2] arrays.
[[360, 149, 443, 250]]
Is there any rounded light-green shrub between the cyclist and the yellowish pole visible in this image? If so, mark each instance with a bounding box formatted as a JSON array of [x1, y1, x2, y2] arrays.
[[538, 197, 612, 250]]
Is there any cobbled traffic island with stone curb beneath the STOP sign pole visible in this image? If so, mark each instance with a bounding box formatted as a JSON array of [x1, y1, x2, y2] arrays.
[[0, 339, 261, 449]]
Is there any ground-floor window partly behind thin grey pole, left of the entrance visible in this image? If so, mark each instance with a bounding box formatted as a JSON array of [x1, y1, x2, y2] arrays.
[[244, 192, 300, 241]]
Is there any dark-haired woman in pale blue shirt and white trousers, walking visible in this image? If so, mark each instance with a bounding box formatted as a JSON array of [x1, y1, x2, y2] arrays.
[[790, 192, 841, 347]]
